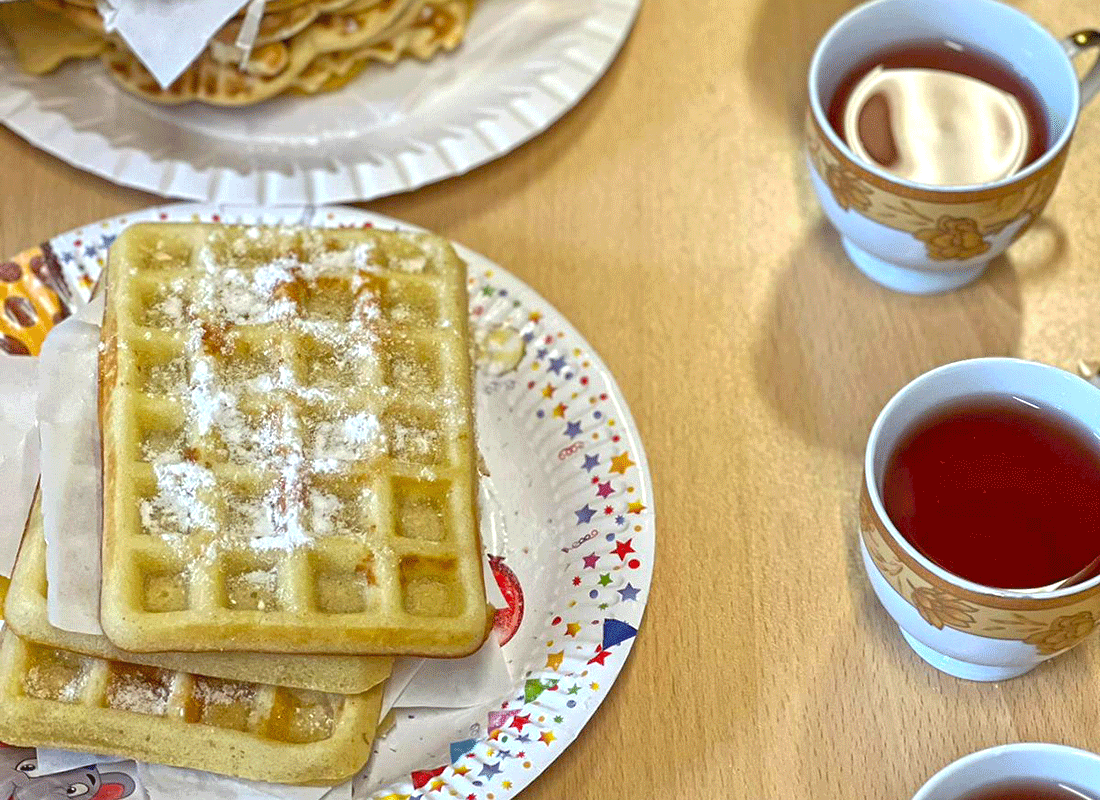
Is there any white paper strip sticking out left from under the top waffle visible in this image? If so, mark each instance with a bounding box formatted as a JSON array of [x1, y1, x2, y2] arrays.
[[36, 298, 103, 634]]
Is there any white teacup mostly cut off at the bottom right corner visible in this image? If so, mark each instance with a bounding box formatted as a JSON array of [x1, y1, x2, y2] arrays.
[[913, 743, 1100, 800]]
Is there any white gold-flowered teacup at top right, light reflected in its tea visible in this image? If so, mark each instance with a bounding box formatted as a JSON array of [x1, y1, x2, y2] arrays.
[[806, 0, 1100, 294]]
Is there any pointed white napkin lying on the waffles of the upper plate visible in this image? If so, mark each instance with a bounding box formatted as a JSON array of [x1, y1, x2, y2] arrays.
[[98, 0, 251, 87]]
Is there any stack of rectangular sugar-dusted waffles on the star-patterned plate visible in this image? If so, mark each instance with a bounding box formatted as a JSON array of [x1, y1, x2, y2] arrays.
[[0, 223, 492, 783]]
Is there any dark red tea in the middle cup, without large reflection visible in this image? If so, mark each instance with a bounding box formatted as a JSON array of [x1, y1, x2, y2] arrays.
[[882, 395, 1100, 589]]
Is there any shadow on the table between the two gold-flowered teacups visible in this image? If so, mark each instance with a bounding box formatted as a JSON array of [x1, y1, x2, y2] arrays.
[[752, 219, 1034, 453]]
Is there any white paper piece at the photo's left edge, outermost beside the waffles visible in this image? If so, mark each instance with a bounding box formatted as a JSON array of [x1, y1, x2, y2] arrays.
[[0, 355, 39, 577]]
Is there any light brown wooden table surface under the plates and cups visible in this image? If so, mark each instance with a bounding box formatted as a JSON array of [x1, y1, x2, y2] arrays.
[[0, 0, 1100, 800]]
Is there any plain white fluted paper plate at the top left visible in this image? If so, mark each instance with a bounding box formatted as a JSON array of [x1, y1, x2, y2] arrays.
[[0, 0, 641, 205]]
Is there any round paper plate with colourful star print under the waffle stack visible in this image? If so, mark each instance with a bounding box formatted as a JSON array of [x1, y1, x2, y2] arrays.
[[0, 204, 655, 800]]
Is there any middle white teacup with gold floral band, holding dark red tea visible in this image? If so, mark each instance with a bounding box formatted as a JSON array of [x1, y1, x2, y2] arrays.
[[859, 359, 1100, 681]]
